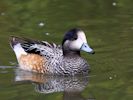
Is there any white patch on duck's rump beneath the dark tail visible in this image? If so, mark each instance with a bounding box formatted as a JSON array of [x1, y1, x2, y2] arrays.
[[13, 43, 27, 59]]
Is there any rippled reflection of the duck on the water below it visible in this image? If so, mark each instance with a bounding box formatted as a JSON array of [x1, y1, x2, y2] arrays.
[[15, 69, 91, 100]]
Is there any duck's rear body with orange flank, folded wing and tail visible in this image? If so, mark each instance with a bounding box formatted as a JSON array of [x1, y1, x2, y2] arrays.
[[10, 37, 63, 74]]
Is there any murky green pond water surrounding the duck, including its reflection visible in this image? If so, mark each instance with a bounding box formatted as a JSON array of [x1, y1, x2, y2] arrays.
[[0, 0, 133, 100]]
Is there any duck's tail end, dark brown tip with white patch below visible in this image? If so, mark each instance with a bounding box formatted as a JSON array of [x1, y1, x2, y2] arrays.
[[10, 36, 27, 58]]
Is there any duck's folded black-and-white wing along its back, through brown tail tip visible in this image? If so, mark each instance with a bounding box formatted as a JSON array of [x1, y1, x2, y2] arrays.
[[10, 36, 63, 59]]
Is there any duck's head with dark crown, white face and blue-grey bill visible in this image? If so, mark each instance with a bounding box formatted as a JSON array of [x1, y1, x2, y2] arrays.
[[62, 28, 94, 54]]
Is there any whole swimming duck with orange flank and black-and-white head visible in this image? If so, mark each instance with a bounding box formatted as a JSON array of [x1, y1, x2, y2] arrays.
[[10, 28, 95, 76]]
